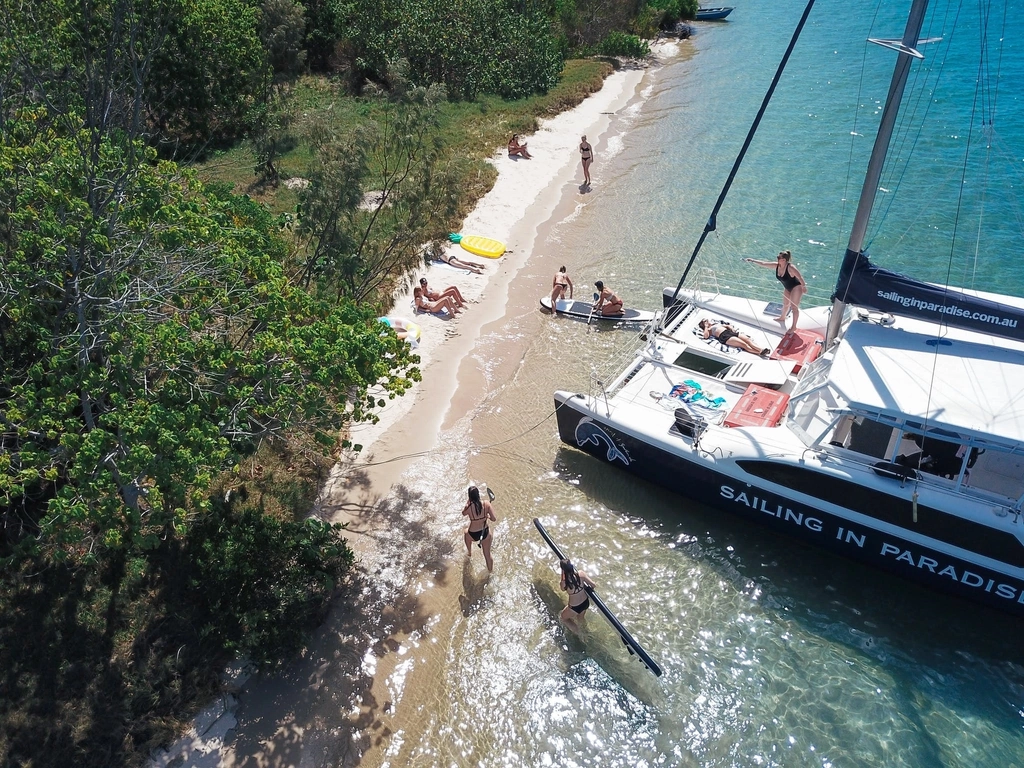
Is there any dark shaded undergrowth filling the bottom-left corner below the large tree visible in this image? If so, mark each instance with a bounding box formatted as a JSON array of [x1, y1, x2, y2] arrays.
[[0, 503, 353, 768]]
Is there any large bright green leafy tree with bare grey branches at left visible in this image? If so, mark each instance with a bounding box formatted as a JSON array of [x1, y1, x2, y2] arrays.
[[0, 113, 419, 561]]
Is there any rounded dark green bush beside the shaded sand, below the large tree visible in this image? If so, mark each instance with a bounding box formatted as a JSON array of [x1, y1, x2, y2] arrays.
[[185, 505, 354, 665]]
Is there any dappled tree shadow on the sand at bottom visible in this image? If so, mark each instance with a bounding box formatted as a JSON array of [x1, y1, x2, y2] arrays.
[[232, 479, 454, 768]]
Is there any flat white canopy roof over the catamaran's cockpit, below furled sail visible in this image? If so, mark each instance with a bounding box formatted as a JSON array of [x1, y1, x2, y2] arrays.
[[829, 322, 1024, 450]]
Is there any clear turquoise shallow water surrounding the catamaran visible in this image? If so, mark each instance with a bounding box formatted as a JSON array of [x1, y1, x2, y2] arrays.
[[372, 0, 1024, 768]]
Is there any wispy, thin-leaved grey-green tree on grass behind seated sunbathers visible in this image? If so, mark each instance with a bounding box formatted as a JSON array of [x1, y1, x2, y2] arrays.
[[298, 74, 458, 301]]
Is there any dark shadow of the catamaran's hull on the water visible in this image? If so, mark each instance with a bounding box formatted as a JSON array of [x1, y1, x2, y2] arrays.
[[553, 447, 1024, 667]]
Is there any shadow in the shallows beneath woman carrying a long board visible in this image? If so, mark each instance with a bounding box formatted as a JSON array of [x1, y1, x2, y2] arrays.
[[531, 568, 659, 712]]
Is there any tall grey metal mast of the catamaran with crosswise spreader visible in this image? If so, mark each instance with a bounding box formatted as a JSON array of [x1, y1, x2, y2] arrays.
[[825, 0, 928, 346]]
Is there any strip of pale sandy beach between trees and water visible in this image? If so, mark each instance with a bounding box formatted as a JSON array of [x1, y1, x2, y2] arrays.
[[144, 43, 677, 768]]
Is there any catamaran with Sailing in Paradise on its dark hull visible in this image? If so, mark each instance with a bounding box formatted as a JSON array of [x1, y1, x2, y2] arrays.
[[554, 0, 1024, 614]]
